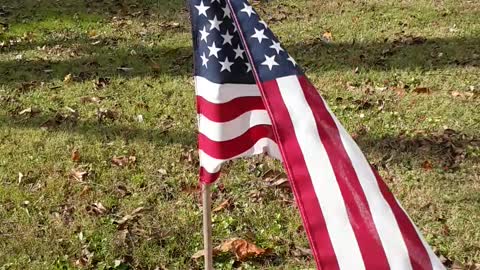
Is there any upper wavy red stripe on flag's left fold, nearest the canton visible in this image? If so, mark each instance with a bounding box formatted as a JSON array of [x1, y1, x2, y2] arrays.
[[197, 96, 265, 122]]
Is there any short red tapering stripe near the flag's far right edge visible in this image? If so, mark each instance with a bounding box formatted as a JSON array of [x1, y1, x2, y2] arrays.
[[372, 168, 433, 270]]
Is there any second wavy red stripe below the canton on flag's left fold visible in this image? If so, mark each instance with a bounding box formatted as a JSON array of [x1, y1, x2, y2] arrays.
[[198, 125, 275, 159]]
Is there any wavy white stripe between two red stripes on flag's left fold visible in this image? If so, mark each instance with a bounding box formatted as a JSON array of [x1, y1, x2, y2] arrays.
[[198, 110, 272, 142]]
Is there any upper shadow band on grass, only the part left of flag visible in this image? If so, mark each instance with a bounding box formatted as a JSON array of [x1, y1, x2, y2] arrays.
[[0, 39, 193, 86]]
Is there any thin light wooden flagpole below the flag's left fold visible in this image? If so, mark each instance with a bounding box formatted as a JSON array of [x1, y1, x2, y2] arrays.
[[202, 184, 213, 270]]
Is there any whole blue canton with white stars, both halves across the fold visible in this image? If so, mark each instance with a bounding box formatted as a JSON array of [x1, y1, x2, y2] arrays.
[[190, 0, 303, 84]]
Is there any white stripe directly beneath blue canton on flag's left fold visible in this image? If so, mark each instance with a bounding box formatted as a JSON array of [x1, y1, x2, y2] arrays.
[[195, 76, 261, 104]]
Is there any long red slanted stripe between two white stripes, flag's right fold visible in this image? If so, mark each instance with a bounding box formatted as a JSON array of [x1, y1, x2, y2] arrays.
[[298, 76, 390, 270]]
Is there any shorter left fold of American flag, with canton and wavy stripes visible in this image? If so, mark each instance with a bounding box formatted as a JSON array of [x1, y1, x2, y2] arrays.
[[190, 0, 281, 183]]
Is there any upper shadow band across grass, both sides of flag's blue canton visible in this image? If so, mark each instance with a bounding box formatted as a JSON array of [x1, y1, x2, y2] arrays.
[[0, 37, 480, 85]]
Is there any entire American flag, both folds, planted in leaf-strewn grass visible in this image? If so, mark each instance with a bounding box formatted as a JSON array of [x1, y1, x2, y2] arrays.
[[190, 0, 444, 270]]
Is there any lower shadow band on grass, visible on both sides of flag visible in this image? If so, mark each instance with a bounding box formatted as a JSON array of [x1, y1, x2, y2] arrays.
[[0, 111, 480, 168]]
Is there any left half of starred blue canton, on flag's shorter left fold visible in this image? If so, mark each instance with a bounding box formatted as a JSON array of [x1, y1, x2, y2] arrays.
[[190, 0, 255, 84]]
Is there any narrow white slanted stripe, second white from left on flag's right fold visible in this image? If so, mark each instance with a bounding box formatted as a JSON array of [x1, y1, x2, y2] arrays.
[[322, 102, 412, 270]]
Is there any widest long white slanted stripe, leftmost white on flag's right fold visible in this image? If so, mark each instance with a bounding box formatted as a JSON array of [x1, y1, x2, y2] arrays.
[[277, 76, 365, 270]]
